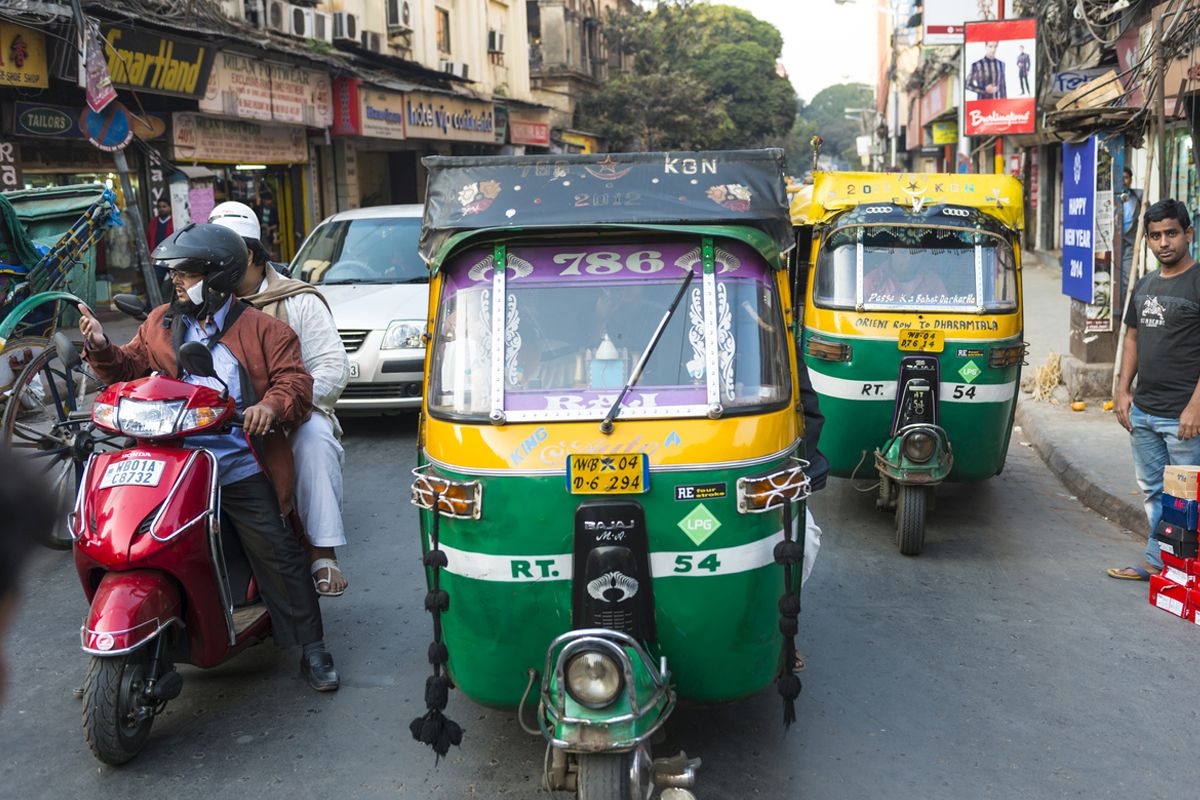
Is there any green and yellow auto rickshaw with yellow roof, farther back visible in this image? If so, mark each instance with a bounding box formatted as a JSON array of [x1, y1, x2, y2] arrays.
[[792, 173, 1025, 555]]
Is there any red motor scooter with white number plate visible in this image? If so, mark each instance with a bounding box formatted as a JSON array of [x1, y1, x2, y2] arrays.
[[66, 337, 271, 764]]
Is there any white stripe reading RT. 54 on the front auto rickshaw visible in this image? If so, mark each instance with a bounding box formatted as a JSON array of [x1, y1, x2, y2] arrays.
[[429, 530, 784, 583]]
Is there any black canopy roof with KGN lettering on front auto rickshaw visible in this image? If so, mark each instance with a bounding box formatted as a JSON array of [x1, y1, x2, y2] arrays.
[[420, 149, 793, 265]]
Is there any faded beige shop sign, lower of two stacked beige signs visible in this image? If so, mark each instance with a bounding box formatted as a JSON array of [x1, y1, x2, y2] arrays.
[[172, 112, 308, 164]]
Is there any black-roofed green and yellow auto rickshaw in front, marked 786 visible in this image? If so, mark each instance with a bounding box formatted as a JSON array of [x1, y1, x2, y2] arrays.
[[413, 151, 814, 800]]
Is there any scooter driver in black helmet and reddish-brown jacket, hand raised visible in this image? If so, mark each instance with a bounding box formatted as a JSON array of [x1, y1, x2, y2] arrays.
[[79, 224, 338, 691]]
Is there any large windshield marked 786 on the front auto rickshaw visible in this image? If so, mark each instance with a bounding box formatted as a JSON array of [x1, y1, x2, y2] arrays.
[[430, 242, 791, 421]]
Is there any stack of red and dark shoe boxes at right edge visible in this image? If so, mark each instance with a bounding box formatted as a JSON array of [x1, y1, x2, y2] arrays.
[[1150, 465, 1200, 625]]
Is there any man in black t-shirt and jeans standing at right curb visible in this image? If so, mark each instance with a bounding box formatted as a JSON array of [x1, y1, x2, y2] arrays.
[[1109, 200, 1200, 581]]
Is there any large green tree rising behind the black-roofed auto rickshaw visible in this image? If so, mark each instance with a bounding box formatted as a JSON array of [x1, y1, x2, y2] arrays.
[[578, 0, 797, 150]]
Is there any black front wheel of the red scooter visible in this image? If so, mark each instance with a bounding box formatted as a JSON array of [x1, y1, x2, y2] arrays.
[[83, 648, 154, 766]]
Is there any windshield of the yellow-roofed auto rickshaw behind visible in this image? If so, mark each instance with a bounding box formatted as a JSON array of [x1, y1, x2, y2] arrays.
[[815, 225, 1016, 313]]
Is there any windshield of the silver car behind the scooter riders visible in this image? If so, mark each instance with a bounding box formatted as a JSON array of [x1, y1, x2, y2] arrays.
[[292, 217, 428, 285]]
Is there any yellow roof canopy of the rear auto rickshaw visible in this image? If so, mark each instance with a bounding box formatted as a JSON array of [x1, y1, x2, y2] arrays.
[[806, 173, 1025, 230]]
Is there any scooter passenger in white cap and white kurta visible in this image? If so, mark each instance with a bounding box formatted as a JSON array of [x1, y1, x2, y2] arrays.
[[209, 201, 350, 597]]
